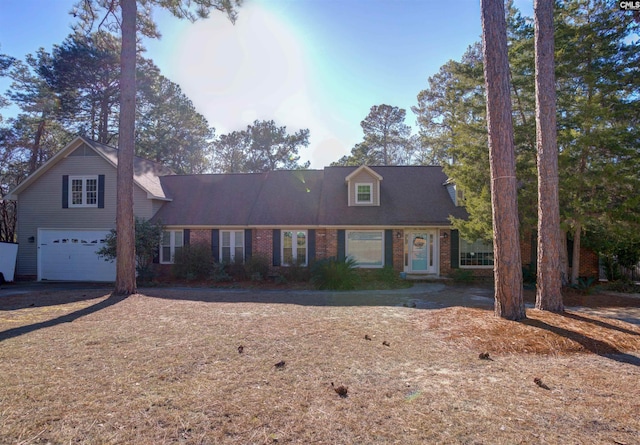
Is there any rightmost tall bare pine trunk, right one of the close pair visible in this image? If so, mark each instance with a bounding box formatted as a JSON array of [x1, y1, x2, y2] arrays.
[[533, 0, 564, 312]]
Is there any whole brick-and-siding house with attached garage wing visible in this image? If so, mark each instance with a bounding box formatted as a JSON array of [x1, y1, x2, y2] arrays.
[[11, 137, 604, 281]]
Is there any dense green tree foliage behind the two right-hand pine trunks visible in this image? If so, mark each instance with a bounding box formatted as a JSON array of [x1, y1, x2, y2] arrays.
[[413, 0, 640, 280]]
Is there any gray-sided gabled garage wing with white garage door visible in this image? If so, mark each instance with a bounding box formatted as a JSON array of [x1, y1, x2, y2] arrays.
[[9, 137, 172, 281]]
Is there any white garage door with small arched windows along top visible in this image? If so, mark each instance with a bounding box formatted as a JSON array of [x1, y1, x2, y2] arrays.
[[38, 229, 116, 281]]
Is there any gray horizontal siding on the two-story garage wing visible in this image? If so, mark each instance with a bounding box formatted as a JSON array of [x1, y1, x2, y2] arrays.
[[16, 146, 153, 275]]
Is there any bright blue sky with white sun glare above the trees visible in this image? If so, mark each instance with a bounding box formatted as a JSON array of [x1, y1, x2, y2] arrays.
[[0, 0, 533, 168]]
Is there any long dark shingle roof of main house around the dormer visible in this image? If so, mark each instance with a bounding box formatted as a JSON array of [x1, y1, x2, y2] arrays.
[[154, 166, 467, 226]]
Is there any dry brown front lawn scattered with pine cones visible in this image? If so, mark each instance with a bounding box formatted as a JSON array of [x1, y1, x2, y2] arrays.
[[0, 284, 640, 445]]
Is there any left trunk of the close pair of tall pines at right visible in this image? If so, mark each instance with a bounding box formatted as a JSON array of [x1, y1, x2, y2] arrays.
[[481, 0, 526, 320]]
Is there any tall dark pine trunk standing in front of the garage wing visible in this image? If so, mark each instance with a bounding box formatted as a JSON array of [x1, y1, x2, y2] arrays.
[[114, 0, 137, 295]]
